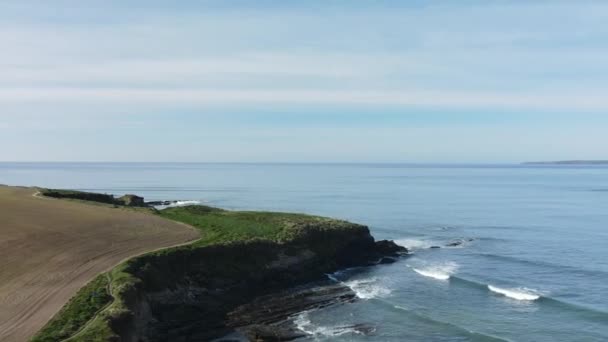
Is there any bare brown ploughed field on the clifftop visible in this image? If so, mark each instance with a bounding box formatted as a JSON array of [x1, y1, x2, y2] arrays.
[[0, 186, 199, 342]]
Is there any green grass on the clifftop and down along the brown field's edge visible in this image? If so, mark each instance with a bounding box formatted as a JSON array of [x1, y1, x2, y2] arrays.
[[33, 206, 353, 342]]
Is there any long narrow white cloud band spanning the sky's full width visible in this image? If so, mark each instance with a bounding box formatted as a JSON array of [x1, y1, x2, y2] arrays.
[[0, 88, 608, 111]]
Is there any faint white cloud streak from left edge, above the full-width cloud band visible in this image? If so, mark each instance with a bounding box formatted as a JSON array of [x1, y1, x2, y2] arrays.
[[0, 54, 363, 84]]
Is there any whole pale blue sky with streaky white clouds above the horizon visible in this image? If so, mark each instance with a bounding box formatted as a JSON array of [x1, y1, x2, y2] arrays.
[[0, 0, 608, 163]]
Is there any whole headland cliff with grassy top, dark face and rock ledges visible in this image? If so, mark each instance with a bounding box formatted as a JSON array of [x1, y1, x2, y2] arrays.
[[35, 206, 407, 342]]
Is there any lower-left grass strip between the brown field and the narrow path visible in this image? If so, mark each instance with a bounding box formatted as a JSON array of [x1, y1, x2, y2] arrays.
[[32, 274, 112, 342]]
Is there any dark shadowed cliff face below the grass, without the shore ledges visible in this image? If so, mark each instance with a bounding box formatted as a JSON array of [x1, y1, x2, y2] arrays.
[[110, 224, 406, 342]]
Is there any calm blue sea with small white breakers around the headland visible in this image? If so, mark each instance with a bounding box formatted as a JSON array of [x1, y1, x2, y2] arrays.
[[0, 163, 608, 341]]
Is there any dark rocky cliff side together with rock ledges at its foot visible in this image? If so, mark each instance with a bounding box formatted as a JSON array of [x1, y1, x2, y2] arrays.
[[113, 232, 407, 342]]
